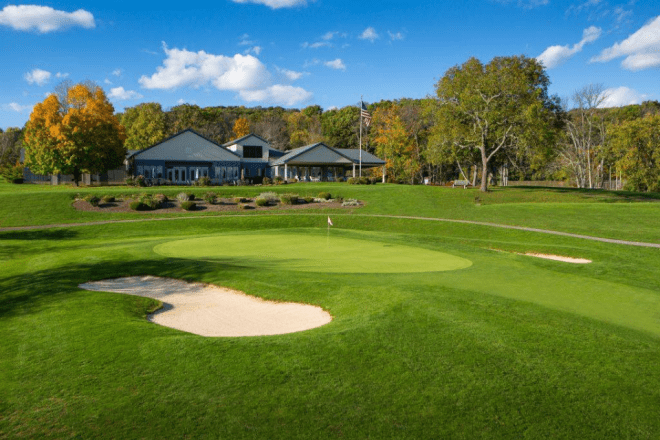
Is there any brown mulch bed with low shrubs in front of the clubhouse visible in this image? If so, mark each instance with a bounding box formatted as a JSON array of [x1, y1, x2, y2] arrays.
[[73, 199, 357, 214]]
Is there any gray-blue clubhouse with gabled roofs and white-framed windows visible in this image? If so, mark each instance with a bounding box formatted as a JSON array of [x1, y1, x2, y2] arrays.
[[126, 129, 385, 185]]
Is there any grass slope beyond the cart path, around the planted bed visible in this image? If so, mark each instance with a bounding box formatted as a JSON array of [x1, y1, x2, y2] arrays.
[[0, 183, 660, 243]]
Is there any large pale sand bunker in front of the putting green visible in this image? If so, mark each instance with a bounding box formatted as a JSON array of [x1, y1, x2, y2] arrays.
[[78, 276, 332, 336]]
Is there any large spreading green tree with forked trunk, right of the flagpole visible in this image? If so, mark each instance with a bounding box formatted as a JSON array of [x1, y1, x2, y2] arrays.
[[436, 56, 560, 191]]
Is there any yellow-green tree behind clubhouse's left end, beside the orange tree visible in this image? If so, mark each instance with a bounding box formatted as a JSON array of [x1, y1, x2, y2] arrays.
[[120, 102, 165, 150]]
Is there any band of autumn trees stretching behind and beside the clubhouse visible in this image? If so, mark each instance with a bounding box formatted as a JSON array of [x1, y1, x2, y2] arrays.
[[5, 56, 660, 191]]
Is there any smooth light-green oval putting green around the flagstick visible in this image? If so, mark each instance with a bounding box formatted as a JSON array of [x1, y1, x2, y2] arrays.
[[154, 233, 472, 273]]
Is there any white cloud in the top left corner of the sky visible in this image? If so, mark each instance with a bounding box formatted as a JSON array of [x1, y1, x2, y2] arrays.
[[0, 5, 96, 34]]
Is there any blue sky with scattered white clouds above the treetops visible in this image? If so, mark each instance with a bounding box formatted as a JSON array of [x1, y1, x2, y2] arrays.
[[0, 0, 660, 129]]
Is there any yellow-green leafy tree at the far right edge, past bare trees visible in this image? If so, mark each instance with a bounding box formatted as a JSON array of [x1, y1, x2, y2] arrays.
[[610, 114, 660, 191]]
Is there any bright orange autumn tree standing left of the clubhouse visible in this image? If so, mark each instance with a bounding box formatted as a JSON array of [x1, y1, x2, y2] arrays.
[[23, 84, 126, 185]]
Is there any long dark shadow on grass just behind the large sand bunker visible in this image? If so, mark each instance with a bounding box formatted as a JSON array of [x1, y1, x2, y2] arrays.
[[0, 259, 249, 319]]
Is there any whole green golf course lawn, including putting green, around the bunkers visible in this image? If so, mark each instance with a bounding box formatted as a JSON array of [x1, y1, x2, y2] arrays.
[[0, 184, 660, 439]]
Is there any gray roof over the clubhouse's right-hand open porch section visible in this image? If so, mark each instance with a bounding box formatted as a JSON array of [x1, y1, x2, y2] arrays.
[[272, 142, 385, 166]]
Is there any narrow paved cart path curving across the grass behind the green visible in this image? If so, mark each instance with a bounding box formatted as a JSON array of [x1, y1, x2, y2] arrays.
[[0, 213, 660, 249]]
